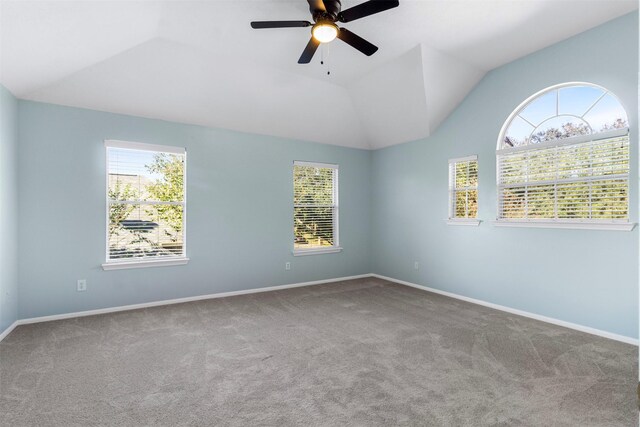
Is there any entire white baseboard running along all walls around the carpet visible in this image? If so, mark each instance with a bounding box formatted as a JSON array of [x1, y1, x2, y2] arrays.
[[0, 273, 638, 346]]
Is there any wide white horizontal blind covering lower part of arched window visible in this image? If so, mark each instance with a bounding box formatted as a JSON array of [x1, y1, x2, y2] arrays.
[[497, 128, 629, 222]]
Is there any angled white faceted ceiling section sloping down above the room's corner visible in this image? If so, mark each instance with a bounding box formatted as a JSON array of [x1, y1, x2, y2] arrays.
[[348, 44, 486, 150]]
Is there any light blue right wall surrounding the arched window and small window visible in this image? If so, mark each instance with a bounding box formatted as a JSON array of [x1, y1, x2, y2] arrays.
[[372, 13, 639, 338]]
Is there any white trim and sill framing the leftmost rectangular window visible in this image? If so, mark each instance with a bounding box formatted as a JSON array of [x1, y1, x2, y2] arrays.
[[102, 139, 189, 271]]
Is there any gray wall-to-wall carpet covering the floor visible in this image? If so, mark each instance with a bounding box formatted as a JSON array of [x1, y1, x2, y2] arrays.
[[0, 279, 638, 427]]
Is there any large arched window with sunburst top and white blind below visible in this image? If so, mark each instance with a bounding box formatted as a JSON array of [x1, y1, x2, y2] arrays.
[[496, 83, 629, 229]]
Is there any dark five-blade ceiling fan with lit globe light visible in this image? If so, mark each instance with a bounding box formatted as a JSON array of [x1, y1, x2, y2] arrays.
[[251, 0, 400, 64]]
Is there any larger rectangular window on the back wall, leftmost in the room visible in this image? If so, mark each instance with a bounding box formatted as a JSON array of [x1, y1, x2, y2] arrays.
[[103, 141, 187, 270]]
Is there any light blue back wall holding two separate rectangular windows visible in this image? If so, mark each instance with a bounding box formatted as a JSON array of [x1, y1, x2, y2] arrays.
[[19, 101, 371, 318]]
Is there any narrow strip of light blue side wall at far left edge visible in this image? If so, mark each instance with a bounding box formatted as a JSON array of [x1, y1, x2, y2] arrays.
[[0, 85, 18, 334]]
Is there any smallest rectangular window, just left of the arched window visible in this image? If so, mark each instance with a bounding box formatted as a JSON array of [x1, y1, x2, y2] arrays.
[[449, 156, 480, 225]]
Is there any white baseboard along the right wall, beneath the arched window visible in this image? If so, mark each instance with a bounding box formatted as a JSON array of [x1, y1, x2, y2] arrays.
[[371, 274, 638, 346]]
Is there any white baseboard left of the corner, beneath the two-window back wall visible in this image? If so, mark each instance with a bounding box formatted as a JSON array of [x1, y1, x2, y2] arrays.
[[7, 274, 371, 332]]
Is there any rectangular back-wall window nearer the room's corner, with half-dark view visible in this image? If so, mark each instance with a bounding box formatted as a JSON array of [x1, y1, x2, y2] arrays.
[[293, 161, 342, 255]]
